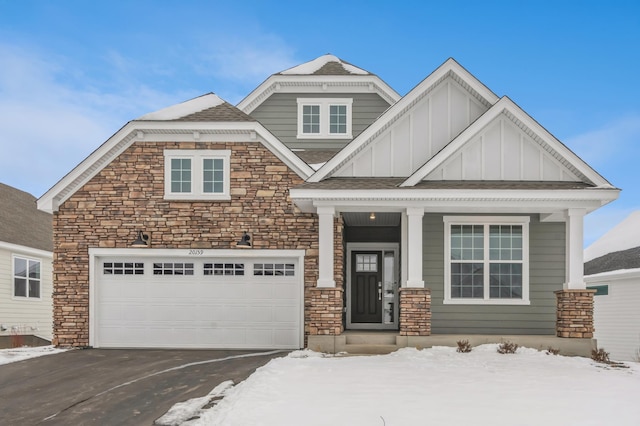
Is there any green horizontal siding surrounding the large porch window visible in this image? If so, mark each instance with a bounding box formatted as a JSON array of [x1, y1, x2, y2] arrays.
[[423, 214, 565, 335]]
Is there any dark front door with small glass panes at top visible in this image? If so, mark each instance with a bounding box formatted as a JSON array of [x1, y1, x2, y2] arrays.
[[351, 251, 382, 324]]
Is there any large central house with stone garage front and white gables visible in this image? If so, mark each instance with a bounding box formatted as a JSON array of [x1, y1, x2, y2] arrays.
[[38, 55, 619, 352]]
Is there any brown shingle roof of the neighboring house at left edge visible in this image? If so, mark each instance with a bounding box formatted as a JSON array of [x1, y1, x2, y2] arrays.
[[0, 183, 53, 251]]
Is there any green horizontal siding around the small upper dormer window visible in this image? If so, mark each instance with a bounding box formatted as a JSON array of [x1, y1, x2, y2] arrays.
[[251, 93, 389, 150]]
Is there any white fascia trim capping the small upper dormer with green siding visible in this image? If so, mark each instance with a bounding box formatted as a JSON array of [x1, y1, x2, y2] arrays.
[[236, 74, 401, 114]]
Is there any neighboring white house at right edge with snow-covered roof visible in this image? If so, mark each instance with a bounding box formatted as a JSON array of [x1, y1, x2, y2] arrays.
[[584, 211, 640, 361]]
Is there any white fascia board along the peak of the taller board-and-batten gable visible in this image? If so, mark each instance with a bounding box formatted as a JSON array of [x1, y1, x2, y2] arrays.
[[309, 58, 499, 182]]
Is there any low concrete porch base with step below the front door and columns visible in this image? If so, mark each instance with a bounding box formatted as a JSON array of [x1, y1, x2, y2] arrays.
[[308, 331, 597, 357]]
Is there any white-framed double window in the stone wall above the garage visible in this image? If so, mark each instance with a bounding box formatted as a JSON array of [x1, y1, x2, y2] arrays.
[[164, 149, 231, 200]]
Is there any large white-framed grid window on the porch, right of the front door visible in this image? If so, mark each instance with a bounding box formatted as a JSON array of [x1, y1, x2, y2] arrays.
[[444, 216, 529, 305]]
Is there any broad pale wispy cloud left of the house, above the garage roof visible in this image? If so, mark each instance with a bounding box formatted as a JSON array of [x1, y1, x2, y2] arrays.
[[0, 44, 196, 196]]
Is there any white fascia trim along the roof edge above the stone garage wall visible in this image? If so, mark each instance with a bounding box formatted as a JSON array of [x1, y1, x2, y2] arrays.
[[37, 121, 314, 213]]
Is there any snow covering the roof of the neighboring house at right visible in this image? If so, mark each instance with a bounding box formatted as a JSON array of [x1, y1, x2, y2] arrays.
[[584, 210, 640, 262]]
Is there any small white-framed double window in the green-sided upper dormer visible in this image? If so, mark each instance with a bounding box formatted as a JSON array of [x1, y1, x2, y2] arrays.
[[298, 98, 353, 139]]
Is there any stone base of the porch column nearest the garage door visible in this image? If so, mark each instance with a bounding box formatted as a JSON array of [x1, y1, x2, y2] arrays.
[[304, 287, 344, 336]]
